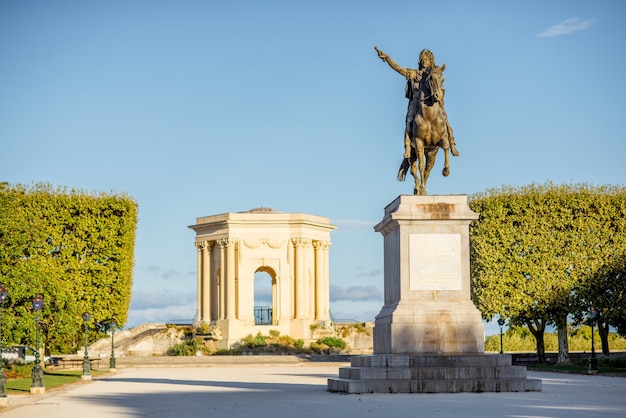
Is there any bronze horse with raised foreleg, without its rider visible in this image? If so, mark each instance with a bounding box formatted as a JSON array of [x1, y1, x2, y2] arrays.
[[398, 64, 450, 195]]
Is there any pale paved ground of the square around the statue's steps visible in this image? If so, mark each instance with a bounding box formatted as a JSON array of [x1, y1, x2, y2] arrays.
[[0, 357, 626, 418]]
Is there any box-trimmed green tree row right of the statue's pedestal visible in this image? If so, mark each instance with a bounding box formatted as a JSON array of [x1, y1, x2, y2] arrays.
[[470, 183, 626, 363]]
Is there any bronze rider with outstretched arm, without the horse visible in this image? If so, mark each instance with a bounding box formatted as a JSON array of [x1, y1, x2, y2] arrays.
[[374, 47, 459, 159]]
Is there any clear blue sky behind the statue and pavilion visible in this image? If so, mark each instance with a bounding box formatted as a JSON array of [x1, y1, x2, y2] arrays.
[[0, 0, 626, 333]]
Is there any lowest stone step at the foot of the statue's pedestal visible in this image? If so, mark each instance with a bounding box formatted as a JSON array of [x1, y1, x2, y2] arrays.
[[328, 378, 541, 393]]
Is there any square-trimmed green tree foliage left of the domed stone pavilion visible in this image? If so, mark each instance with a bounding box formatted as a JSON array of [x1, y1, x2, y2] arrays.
[[0, 183, 137, 353]]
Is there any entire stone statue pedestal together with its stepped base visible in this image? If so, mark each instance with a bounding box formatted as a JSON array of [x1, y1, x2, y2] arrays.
[[328, 195, 541, 393]]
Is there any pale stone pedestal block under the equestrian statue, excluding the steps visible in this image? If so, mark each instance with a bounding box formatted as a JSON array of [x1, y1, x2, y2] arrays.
[[374, 195, 485, 354]]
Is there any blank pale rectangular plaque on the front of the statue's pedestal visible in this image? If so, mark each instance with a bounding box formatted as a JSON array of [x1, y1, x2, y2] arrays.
[[409, 234, 462, 290]]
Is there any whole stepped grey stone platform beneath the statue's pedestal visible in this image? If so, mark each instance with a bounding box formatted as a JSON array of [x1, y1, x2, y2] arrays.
[[327, 354, 541, 393]]
